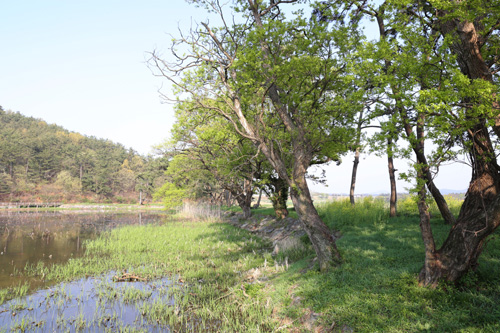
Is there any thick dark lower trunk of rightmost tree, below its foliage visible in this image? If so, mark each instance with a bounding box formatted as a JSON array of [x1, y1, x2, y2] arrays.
[[419, 125, 500, 286]]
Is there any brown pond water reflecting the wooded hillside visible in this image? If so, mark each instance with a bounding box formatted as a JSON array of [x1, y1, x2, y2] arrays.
[[0, 211, 166, 288]]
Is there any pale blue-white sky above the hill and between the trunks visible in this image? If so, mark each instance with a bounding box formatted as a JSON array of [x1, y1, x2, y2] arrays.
[[0, 0, 471, 194]]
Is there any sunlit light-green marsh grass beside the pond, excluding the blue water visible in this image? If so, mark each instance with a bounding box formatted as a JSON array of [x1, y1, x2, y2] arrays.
[[4, 215, 282, 331]]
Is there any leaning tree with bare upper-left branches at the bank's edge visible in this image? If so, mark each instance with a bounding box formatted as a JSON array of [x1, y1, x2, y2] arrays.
[[151, 0, 357, 270]]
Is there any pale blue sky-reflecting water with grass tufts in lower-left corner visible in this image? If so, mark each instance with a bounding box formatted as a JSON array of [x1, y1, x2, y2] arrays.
[[0, 273, 181, 332]]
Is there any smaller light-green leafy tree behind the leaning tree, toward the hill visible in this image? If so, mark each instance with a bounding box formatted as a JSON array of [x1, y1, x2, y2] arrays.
[[166, 102, 261, 218]]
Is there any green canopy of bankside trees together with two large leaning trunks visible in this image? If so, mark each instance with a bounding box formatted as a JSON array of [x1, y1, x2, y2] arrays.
[[150, 0, 500, 285]]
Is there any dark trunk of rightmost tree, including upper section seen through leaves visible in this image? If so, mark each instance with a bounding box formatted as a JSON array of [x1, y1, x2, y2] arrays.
[[419, 11, 500, 286]]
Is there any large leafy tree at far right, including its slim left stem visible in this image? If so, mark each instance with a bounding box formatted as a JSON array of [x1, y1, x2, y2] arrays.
[[332, 1, 500, 286]]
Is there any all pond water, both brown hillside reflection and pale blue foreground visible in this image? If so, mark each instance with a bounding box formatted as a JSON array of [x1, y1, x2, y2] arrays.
[[0, 212, 183, 332]]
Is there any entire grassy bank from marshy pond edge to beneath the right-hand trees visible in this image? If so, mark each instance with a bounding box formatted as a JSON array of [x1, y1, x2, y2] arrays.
[[0, 199, 500, 332]]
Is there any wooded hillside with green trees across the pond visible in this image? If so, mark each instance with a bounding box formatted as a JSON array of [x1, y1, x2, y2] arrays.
[[0, 107, 167, 202]]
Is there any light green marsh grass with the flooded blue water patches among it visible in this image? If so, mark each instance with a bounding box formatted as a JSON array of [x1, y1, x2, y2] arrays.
[[0, 215, 282, 332]]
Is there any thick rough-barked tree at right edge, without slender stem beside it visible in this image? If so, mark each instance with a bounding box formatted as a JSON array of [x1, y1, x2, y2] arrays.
[[411, 1, 500, 286]]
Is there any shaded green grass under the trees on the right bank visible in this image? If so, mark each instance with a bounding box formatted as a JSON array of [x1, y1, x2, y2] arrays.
[[262, 199, 500, 332]]
